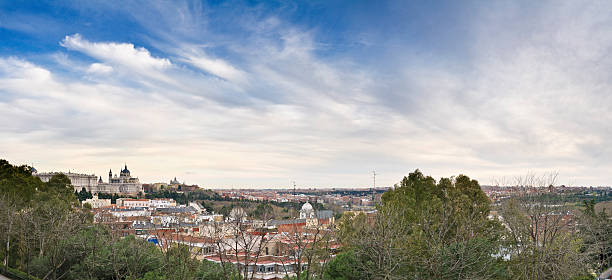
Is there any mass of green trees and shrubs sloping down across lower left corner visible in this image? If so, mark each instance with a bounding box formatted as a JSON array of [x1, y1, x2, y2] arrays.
[[0, 160, 237, 280]]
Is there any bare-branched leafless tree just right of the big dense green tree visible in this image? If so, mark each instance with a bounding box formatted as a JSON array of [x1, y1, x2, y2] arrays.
[[500, 173, 587, 279]]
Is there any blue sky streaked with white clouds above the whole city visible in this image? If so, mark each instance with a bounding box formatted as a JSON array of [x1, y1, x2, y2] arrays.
[[0, 0, 612, 188]]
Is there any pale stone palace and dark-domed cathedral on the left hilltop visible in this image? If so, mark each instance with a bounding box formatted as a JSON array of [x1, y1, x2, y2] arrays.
[[32, 165, 144, 194]]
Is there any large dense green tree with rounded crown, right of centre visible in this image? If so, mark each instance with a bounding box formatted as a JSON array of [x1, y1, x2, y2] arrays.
[[339, 170, 504, 279]]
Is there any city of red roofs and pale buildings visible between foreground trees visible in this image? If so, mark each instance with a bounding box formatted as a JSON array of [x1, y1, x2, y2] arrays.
[[3, 164, 612, 279]]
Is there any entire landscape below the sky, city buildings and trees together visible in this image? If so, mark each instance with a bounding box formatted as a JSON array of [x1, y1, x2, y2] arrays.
[[0, 160, 612, 280]]
